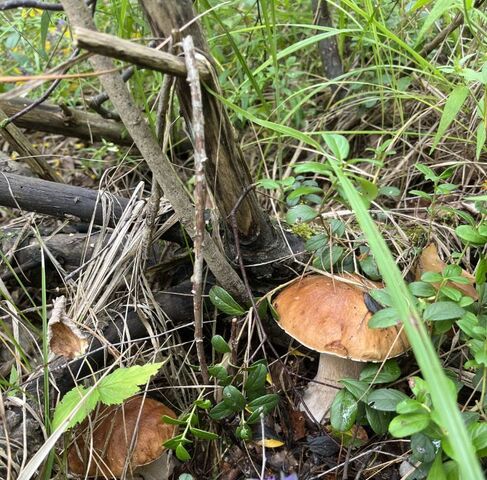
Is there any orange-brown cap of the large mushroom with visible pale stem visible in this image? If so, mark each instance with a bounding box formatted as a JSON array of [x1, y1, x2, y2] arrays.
[[273, 275, 409, 362]]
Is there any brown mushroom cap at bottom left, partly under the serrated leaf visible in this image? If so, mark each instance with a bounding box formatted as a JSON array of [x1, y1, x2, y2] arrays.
[[68, 396, 176, 478]]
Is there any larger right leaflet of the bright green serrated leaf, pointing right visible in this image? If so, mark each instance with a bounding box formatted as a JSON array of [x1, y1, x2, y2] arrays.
[[97, 363, 163, 405]]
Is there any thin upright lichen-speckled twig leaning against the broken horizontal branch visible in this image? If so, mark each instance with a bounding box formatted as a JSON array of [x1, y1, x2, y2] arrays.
[[183, 35, 210, 385]]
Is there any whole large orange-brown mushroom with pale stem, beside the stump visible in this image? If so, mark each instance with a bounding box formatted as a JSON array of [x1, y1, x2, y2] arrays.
[[273, 275, 409, 422]]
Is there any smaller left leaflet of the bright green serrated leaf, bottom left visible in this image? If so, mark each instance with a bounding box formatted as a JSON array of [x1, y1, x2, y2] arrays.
[[51, 385, 100, 430]]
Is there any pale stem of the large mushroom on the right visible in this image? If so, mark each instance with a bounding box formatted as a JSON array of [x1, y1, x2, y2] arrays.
[[300, 353, 363, 422]]
